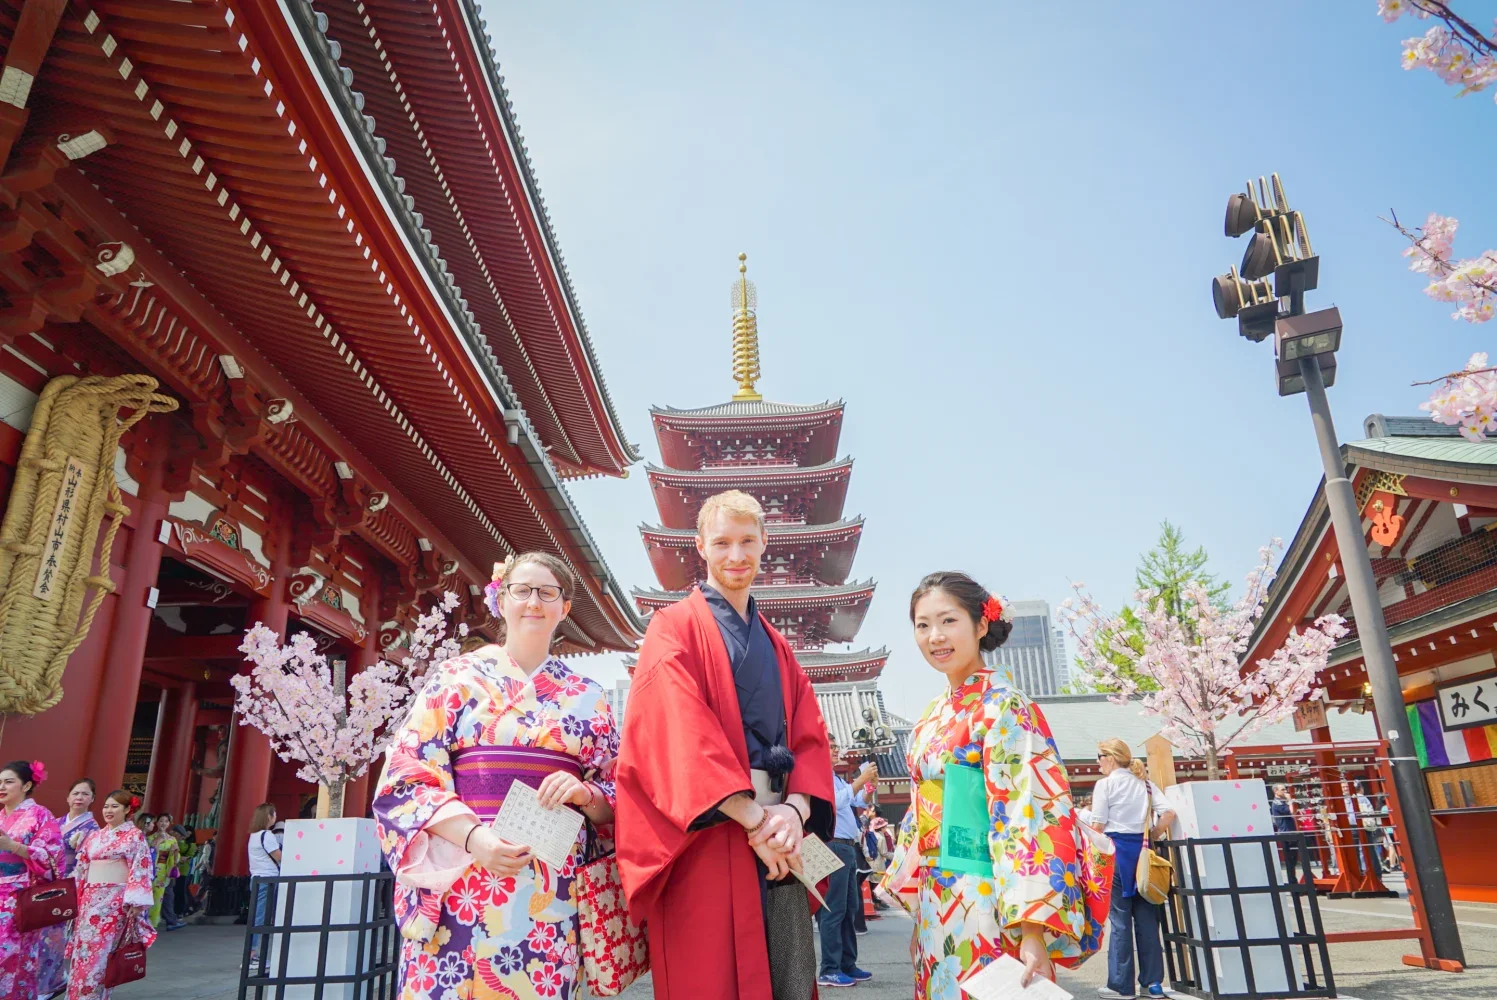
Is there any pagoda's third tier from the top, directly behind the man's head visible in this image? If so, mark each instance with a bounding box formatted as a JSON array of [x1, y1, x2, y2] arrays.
[[639, 518, 862, 590]]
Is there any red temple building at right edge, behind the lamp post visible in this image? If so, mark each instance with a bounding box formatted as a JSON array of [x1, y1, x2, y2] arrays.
[[1244, 415, 1497, 903]]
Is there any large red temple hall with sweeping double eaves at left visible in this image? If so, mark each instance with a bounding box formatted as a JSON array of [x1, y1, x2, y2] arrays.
[[0, 0, 641, 874]]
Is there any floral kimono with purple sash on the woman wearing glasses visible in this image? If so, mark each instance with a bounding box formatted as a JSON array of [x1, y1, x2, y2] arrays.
[[374, 645, 618, 1000]]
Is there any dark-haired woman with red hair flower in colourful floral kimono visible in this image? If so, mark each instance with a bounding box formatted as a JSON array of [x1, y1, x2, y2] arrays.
[[883, 573, 1111, 1000]]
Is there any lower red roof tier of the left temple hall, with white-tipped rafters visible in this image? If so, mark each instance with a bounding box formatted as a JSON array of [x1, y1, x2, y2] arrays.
[[28, 0, 641, 648]]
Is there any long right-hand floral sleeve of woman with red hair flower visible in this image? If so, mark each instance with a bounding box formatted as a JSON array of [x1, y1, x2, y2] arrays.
[[982, 687, 1084, 960]]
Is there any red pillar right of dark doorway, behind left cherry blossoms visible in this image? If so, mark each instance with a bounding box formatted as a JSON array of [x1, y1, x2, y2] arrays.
[[213, 524, 288, 876]]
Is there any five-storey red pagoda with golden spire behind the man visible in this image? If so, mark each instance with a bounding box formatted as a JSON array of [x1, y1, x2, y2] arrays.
[[635, 256, 903, 769]]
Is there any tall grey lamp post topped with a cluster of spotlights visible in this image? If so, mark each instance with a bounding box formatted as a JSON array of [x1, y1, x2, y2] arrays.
[[1213, 174, 1466, 966]]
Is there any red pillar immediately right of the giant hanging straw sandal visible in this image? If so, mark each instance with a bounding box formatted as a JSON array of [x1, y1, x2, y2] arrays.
[[87, 442, 171, 792]]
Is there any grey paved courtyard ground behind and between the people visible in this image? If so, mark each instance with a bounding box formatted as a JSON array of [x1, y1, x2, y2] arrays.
[[112, 900, 1497, 1000]]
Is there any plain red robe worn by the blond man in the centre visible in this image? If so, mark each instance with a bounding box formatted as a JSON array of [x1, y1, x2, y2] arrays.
[[615, 590, 832, 1000]]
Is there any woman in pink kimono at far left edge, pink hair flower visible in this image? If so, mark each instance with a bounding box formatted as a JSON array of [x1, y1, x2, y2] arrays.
[[0, 760, 63, 1000]]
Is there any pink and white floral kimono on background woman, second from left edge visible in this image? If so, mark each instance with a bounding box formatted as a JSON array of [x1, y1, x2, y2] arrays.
[[67, 823, 156, 1000]]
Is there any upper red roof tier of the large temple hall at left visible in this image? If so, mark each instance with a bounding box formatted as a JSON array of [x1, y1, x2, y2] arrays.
[[303, 0, 639, 476]]
